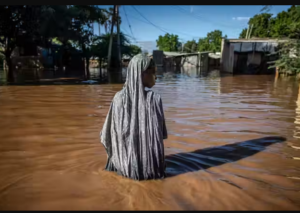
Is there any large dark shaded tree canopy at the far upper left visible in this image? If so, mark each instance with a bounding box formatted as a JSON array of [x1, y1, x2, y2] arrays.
[[0, 5, 110, 82]]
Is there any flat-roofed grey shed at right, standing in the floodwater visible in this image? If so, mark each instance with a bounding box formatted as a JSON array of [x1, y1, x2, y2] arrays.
[[220, 38, 287, 74]]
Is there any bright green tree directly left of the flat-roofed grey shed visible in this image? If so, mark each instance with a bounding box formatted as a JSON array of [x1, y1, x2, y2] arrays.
[[198, 30, 227, 52]]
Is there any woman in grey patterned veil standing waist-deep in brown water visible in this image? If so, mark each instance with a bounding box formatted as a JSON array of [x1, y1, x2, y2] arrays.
[[100, 54, 167, 180]]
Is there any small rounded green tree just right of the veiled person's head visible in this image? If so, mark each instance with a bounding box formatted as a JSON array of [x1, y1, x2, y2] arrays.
[[156, 33, 181, 52]]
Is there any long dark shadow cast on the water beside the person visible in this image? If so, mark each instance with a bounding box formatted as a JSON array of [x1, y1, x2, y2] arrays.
[[165, 136, 286, 177]]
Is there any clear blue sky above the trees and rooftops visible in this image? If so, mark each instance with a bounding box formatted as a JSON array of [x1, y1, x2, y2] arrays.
[[94, 5, 290, 52]]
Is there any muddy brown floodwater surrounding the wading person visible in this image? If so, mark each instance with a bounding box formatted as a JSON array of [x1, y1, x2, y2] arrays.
[[0, 70, 300, 210]]
